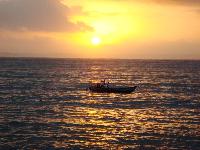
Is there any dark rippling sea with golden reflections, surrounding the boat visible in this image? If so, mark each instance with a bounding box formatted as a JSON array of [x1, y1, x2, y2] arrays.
[[0, 58, 200, 149]]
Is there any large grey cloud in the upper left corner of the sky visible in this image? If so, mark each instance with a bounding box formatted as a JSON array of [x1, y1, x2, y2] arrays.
[[0, 0, 93, 32]]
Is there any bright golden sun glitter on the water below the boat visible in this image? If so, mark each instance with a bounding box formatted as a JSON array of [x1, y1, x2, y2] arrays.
[[45, 95, 199, 148]]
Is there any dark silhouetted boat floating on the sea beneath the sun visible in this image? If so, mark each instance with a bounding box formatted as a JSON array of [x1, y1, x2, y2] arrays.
[[89, 83, 137, 94]]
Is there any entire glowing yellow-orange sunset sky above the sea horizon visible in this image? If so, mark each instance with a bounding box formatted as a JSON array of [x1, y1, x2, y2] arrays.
[[0, 0, 200, 59]]
